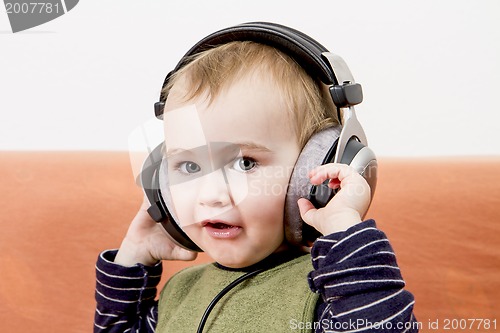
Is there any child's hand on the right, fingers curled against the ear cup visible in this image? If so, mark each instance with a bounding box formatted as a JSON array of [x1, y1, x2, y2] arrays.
[[298, 163, 371, 235]]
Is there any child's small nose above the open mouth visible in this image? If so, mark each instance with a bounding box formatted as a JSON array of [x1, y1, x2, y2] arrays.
[[198, 169, 232, 207]]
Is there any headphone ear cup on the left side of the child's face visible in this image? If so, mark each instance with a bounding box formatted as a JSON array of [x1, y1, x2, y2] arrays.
[[141, 144, 202, 252]]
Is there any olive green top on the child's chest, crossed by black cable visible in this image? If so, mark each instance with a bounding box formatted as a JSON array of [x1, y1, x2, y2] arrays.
[[156, 254, 318, 333]]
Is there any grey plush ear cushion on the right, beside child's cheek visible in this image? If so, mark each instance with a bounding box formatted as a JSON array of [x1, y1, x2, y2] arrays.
[[284, 126, 342, 246]]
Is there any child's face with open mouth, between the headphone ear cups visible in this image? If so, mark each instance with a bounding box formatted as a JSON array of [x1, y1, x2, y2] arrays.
[[164, 75, 300, 268]]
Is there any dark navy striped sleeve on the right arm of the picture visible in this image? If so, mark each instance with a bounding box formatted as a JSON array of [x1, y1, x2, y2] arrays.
[[308, 220, 419, 332]]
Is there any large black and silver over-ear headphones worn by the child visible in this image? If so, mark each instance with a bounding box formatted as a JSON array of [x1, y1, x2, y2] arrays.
[[140, 22, 377, 252]]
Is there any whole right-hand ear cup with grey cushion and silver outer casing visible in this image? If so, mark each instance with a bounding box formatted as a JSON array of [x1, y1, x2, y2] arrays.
[[284, 126, 377, 246]]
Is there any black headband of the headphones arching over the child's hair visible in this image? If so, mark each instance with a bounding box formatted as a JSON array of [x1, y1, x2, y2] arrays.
[[155, 22, 363, 118]]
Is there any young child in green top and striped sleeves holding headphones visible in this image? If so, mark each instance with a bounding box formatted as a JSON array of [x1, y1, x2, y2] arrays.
[[94, 27, 418, 332]]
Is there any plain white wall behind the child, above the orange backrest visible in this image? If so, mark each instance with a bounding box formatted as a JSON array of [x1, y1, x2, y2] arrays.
[[0, 0, 500, 156]]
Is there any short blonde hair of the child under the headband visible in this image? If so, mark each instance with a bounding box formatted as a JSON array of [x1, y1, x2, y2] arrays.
[[162, 41, 338, 147]]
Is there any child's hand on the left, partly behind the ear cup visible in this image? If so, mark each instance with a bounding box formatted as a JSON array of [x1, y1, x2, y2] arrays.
[[114, 198, 197, 267]]
